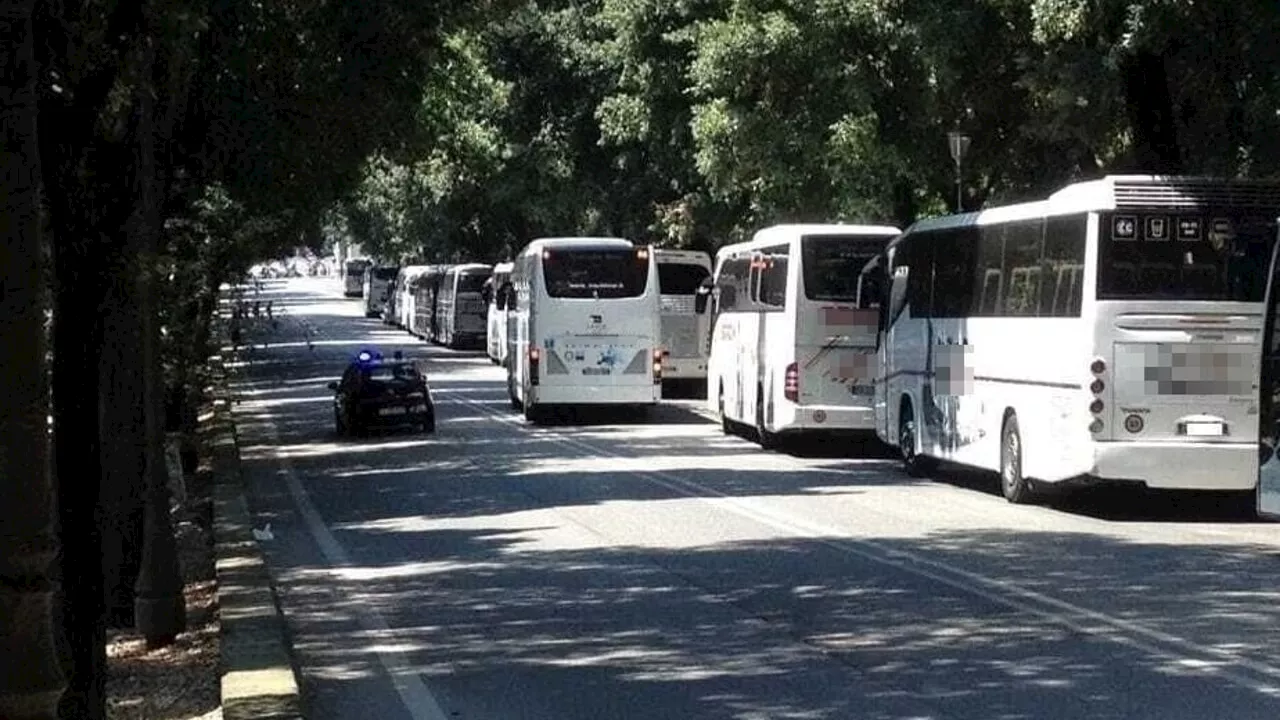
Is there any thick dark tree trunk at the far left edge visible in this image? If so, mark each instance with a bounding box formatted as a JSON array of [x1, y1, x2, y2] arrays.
[[0, 0, 65, 720]]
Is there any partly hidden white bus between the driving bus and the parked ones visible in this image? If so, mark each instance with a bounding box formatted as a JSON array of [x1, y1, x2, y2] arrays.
[[654, 247, 712, 386]]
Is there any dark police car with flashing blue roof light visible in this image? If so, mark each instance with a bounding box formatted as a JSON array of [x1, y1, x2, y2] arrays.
[[329, 350, 435, 436]]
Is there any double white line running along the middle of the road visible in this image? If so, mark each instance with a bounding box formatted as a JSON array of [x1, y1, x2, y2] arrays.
[[444, 391, 1280, 697]]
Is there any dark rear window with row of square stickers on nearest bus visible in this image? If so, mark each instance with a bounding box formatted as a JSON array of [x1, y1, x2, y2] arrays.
[[1098, 213, 1276, 302]]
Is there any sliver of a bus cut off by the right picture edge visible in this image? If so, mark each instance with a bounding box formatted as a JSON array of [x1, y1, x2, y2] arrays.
[[1257, 221, 1280, 520]]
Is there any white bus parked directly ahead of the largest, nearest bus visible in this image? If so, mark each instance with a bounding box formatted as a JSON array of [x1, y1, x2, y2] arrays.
[[699, 224, 901, 446]]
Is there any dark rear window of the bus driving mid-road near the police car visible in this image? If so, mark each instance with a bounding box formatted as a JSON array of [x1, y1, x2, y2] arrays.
[[543, 250, 649, 299]]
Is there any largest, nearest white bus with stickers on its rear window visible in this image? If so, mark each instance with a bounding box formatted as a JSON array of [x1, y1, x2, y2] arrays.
[[876, 176, 1280, 502]]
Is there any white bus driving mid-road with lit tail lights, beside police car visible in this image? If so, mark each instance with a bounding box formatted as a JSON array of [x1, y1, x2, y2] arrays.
[[507, 238, 662, 423]]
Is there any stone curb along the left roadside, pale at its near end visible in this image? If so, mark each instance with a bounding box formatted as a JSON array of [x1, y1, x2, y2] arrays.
[[210, 351, 303, 720]]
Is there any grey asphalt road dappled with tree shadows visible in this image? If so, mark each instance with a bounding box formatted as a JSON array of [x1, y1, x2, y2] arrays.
[[225, 278, 1280, 720]]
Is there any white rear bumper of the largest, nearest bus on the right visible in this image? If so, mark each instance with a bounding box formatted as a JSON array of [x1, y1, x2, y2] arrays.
[[1089, 442, 1258, 491]]
